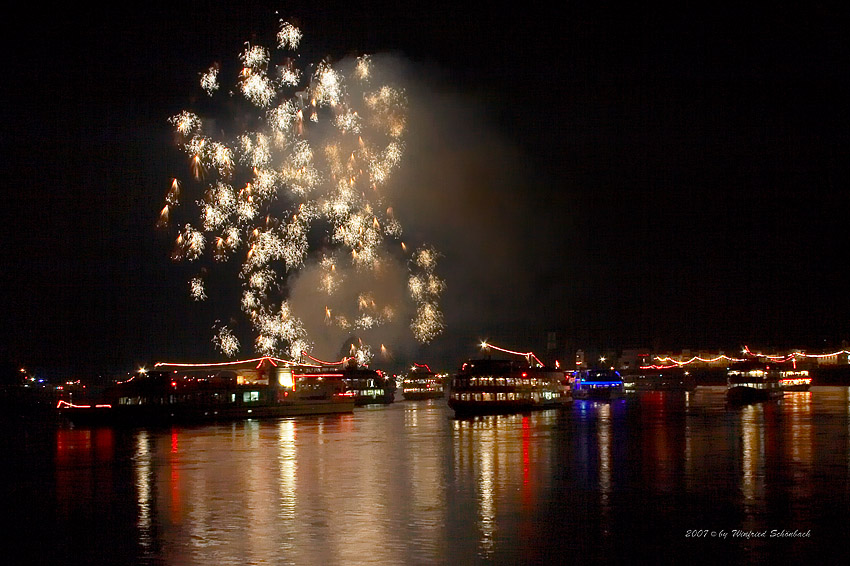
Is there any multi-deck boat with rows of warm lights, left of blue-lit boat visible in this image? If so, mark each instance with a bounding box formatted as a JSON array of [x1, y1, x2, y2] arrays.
[[448, 342, 571, 416]]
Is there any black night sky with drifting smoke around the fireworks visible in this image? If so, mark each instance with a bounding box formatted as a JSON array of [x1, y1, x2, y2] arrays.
[[0, 2, 850, 373]]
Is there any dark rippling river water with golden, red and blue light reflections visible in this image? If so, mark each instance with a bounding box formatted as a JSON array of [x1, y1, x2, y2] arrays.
[[0, 387, 850, 565]]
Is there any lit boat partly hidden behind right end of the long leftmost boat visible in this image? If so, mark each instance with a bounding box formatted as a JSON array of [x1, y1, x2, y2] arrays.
[[301, 352, 396, 406]]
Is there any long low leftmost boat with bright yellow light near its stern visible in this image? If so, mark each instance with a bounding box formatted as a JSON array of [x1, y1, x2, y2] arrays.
[[57, 356, 355, 425]]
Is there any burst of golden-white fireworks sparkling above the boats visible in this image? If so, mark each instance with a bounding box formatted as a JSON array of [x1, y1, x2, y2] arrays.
[[164, 22, 445, 363]]
